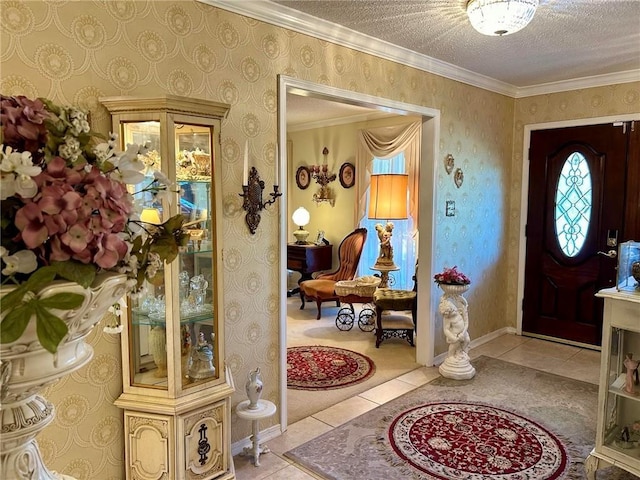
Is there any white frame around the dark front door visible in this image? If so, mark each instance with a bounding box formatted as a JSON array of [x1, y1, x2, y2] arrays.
[[516, 113, 640, 349]]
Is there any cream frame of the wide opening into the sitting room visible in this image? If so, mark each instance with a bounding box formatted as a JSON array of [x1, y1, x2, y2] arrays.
[[276, 75, 444, 431]]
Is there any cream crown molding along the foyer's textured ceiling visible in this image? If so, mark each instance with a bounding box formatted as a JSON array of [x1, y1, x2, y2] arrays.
[[204, 0, 640, 98]]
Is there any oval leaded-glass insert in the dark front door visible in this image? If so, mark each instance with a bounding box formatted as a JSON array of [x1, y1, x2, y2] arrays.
[[555, 152, 593, 257]]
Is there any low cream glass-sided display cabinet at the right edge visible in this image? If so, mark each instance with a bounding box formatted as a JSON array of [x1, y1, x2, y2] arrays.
[[585, 287, 640, 480]]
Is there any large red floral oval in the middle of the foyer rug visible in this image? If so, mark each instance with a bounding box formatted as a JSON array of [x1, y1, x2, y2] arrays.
[[389, 402, 568, 480]]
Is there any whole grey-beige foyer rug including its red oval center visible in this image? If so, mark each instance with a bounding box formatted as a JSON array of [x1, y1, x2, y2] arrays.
[[285, 357, 637, 480]]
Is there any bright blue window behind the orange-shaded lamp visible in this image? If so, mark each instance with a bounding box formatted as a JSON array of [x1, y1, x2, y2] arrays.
[[358, 153, 416, 290]]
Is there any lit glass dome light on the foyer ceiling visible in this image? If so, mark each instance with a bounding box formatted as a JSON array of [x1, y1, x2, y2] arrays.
[[467, 0, 538, 36]]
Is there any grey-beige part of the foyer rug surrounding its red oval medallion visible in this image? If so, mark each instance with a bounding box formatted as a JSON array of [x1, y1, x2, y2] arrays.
[[285, 357, 637, 480]]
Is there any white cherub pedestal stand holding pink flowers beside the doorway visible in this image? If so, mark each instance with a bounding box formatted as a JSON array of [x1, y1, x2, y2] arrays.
[[438, 284, 476, 380]]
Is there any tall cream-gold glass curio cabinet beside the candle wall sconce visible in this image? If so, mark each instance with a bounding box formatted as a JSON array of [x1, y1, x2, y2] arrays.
[[101, 96, 235, 480]]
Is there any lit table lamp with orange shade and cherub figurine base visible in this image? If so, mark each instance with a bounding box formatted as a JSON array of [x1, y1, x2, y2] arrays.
[[368, 173, 409, 269]]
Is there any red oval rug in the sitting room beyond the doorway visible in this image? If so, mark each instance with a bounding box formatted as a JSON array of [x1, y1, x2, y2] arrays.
[[287, 345, 376, 390]]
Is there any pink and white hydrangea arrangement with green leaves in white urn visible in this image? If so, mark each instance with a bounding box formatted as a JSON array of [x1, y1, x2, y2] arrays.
[[0, 95, 188, 352]]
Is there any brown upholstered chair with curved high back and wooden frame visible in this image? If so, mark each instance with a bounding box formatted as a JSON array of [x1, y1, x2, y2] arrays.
[[300, 228, 367, 320]]
